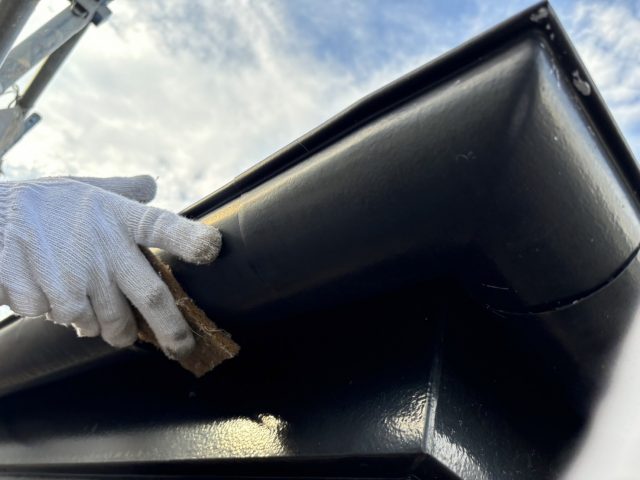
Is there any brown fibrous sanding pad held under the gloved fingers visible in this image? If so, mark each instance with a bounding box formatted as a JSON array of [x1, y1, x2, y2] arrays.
[[133, 247, 240, 377]]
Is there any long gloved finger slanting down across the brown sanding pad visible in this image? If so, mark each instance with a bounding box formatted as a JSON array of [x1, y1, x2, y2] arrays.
[[115, 245, 195, 358]]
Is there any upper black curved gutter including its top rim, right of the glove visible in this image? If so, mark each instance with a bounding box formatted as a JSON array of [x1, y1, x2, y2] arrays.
[[164, 3, 640, 316]]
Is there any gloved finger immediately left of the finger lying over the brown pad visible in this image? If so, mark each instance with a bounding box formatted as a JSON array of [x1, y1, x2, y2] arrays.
[[89, 281, 138, 347]]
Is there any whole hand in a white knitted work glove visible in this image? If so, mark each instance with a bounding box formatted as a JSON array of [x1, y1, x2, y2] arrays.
[[0, 175, 222, 358]]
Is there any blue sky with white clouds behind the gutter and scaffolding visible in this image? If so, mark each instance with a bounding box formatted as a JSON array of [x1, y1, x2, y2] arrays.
[[3, 0, 640, 211]]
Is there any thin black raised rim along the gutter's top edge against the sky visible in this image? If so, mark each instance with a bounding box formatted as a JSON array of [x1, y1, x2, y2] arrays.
[[181, 2, 640, 218]]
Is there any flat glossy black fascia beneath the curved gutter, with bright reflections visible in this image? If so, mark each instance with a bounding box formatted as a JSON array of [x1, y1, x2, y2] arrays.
[[0, 281, 579, 478]]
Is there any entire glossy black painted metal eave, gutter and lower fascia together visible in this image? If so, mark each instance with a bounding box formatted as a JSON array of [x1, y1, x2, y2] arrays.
[[0, 4, 640, 479]]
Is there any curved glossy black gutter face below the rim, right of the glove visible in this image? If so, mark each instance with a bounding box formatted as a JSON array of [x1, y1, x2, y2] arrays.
[[174, 30, 640, 318]]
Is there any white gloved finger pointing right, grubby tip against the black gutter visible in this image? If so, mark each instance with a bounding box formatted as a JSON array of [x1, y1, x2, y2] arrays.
[[126, 205, 222, 264]]
